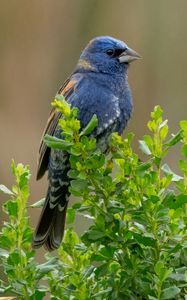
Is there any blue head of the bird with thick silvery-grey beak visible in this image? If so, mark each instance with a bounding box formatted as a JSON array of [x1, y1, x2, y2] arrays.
[[78, 36, 140, 74]]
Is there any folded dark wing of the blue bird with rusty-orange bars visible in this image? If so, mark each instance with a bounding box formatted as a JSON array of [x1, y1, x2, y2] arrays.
[[36, 77, 76, 180]]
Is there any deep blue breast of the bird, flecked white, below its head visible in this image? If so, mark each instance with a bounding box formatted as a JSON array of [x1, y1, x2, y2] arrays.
[[68, 72, 132, 135]]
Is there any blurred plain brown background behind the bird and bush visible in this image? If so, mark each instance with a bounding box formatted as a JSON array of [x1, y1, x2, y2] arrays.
[[0, 0, 187, 234]]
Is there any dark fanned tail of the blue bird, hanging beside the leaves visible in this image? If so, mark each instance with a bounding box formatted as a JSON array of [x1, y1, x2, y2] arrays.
[[32, 187, 68, 251]]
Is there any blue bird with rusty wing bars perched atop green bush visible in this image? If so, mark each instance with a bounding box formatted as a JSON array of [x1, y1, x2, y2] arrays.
[[32, 36, 140, 251]]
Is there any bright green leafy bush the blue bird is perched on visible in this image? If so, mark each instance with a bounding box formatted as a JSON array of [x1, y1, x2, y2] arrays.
[[0, 96, 187, 300]]
